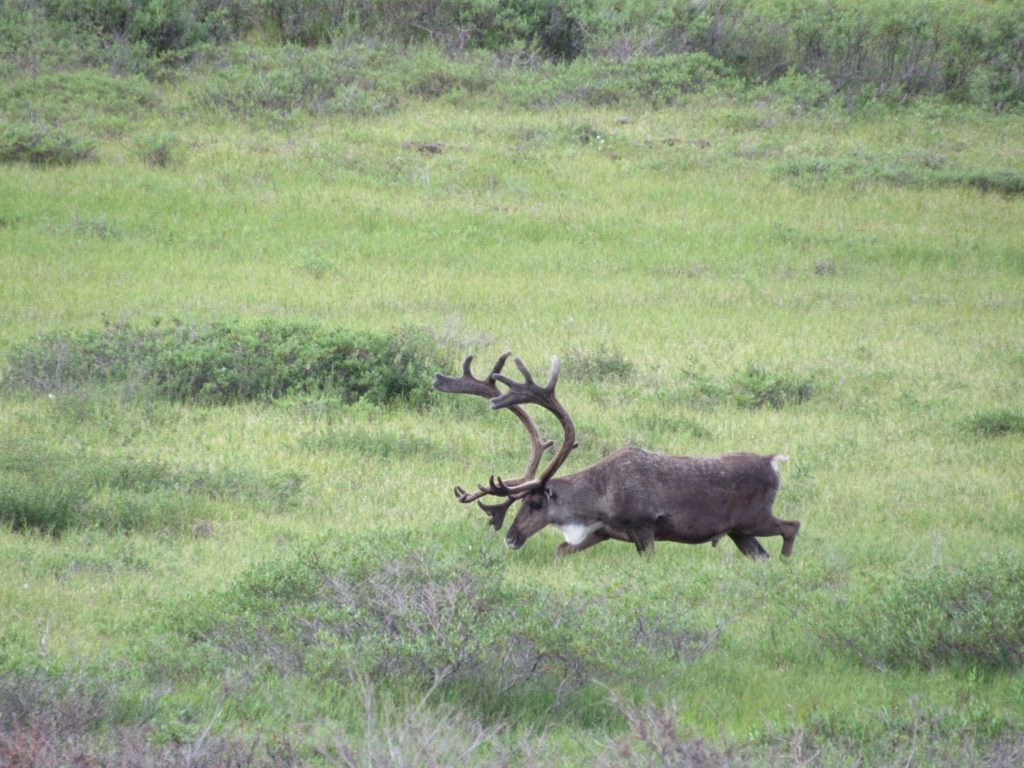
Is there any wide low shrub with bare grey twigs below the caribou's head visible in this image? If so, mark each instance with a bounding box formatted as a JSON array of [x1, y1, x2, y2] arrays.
[[181, 536, 718, 719]]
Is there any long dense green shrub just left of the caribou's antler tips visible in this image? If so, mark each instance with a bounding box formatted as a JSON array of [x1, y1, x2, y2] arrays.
[[4, 321, 446, 404]]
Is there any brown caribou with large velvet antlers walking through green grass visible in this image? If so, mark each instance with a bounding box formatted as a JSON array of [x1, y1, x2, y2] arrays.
[[434, 352, 800, 559]]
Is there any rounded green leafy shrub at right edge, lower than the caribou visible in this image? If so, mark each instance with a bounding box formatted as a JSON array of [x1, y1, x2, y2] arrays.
[[827, 558, 1024, 670]]
